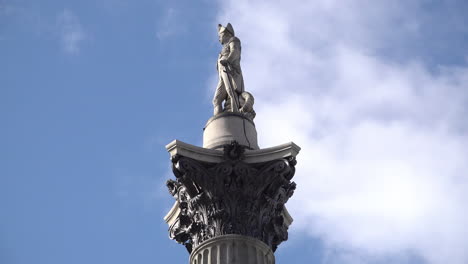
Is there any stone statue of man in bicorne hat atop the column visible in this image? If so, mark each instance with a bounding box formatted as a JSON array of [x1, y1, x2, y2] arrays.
[[213, 23, 255, 119]]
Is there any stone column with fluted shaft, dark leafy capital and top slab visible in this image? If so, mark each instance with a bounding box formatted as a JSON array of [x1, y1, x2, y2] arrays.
[[165, 139, 300, 264]]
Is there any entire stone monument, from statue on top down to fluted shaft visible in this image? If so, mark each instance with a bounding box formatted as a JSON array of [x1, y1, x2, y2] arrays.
[[164, 24, 300, 264]]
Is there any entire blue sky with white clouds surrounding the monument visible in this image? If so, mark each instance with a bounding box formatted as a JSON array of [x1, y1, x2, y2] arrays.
[[0, 0, 468, 264]]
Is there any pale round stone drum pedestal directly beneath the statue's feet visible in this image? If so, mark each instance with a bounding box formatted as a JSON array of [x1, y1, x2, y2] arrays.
[[203, 112, 259, 150]]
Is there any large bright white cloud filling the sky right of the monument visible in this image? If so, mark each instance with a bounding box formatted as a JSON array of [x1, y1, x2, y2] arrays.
[[218, 0, 468, 264]]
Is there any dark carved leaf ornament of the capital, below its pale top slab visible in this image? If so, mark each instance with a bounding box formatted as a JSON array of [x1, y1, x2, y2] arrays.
[[167, 142, 296, 252]]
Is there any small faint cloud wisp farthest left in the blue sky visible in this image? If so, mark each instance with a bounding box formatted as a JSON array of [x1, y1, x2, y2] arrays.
[[57, 9, 86, 54]]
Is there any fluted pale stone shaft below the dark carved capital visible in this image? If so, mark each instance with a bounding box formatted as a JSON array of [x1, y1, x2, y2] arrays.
[[190, 235, 275, 264]]
